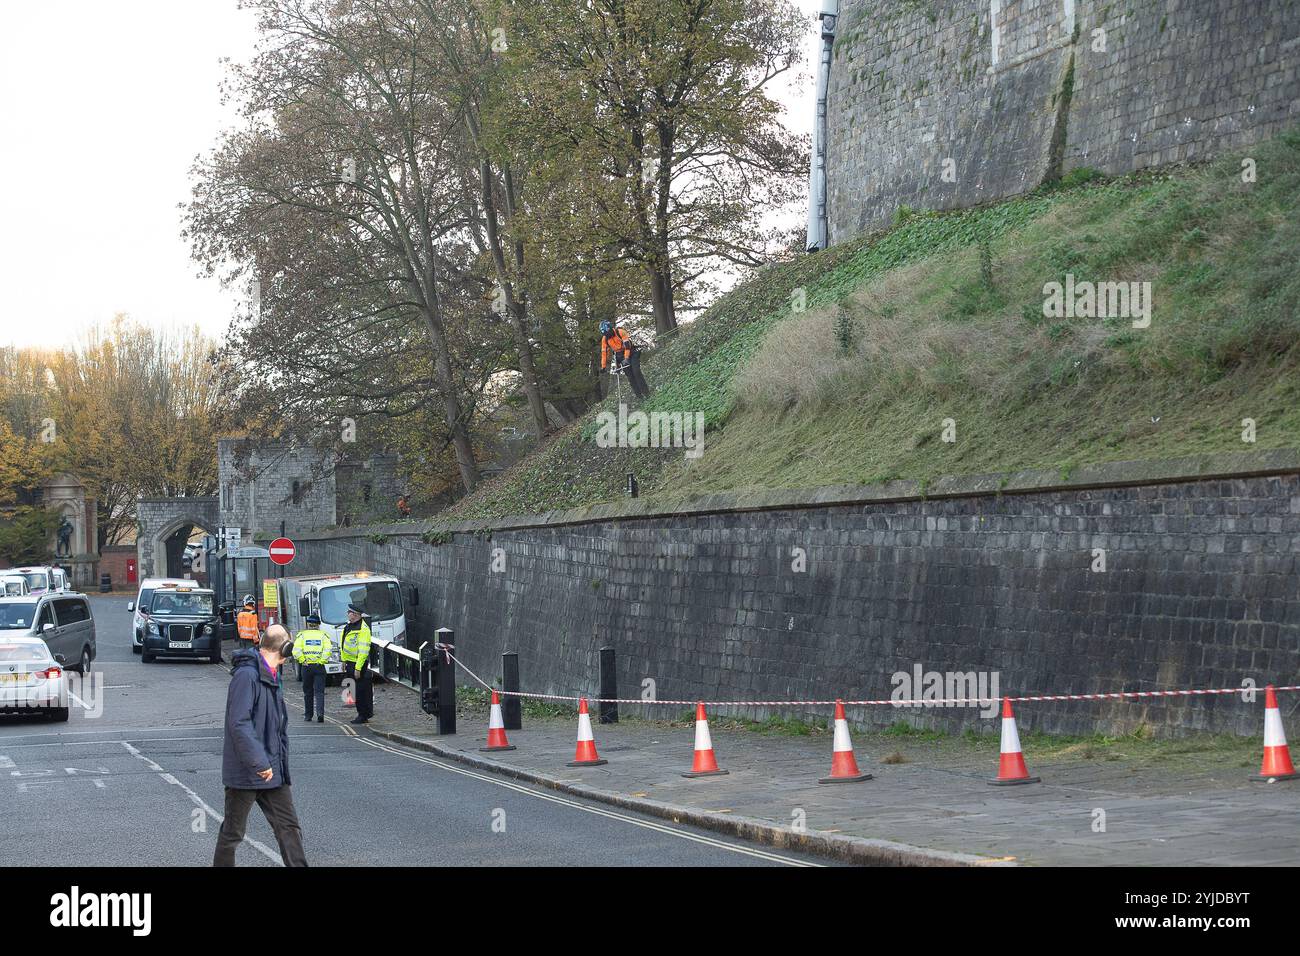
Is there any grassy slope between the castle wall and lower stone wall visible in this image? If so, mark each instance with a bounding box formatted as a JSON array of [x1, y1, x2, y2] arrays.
[[451, 131, 1300, 518]]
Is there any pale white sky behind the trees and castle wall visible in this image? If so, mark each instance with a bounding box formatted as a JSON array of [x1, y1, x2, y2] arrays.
[[0, 0, 820, 347]]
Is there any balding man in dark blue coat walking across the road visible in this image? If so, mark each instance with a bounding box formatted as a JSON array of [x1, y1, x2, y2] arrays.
[[212, 624, 307, 866]]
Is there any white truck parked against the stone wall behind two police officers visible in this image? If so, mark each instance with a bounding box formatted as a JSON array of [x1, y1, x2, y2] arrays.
[[280, 571, 413, 676]]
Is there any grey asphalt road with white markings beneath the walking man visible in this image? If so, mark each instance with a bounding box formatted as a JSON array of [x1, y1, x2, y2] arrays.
[[0, 596, 823, 866]]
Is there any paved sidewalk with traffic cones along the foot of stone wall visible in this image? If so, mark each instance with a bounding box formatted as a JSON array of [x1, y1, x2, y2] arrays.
[[372, 685, 1300, 865]]
